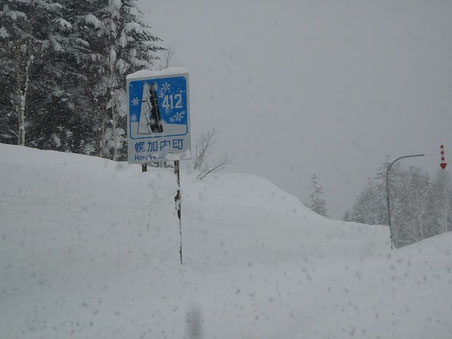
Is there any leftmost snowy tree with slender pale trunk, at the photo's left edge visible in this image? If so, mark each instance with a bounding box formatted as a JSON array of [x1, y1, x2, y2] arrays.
[[0, 0, 61, 145]]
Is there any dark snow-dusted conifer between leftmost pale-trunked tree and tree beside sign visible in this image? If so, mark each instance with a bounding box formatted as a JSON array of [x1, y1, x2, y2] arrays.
[[24, 1, 88, 153]]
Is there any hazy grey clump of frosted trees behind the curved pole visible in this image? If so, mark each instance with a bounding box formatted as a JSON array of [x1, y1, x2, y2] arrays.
[[351, 162, 451, 247]]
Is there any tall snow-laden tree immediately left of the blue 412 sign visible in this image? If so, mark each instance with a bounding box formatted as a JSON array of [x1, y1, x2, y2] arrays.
[[69, 0, 162, 159]]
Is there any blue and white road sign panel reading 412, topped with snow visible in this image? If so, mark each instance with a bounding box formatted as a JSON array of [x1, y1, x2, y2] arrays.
[[127, 68, 191, 163]]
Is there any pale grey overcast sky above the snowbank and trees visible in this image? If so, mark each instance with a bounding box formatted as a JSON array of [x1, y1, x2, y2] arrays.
[[142, 0, 452, 218]]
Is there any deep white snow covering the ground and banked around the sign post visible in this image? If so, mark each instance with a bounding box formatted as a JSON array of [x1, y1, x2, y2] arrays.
[[0, 144, 452, 339]]
